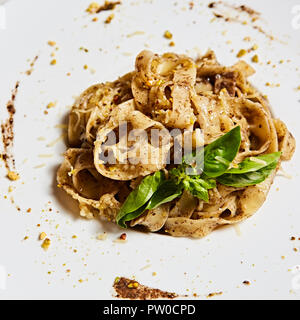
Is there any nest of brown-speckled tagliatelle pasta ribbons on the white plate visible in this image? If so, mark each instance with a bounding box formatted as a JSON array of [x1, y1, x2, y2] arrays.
[[57, 51, 295, 237]]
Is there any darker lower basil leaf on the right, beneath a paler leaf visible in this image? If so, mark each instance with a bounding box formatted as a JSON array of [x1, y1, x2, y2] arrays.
[[217, 161, 277, 188]]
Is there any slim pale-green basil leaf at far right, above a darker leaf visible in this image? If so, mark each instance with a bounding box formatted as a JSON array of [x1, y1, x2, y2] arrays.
[[226, 152, 281, 174]]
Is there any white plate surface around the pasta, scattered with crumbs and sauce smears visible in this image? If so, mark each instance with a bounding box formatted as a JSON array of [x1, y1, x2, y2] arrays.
[[0, 0, 300, 299]]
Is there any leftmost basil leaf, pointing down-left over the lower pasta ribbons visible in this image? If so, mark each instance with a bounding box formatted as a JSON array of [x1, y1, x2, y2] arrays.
[[116, 171, 165, 226]]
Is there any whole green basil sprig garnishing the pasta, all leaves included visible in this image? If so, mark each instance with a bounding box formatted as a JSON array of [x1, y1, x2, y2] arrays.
[[116, 126, 281, 228]]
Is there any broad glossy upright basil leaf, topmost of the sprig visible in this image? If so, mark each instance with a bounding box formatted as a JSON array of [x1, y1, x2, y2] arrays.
[[203, 126, 241, 178]]
